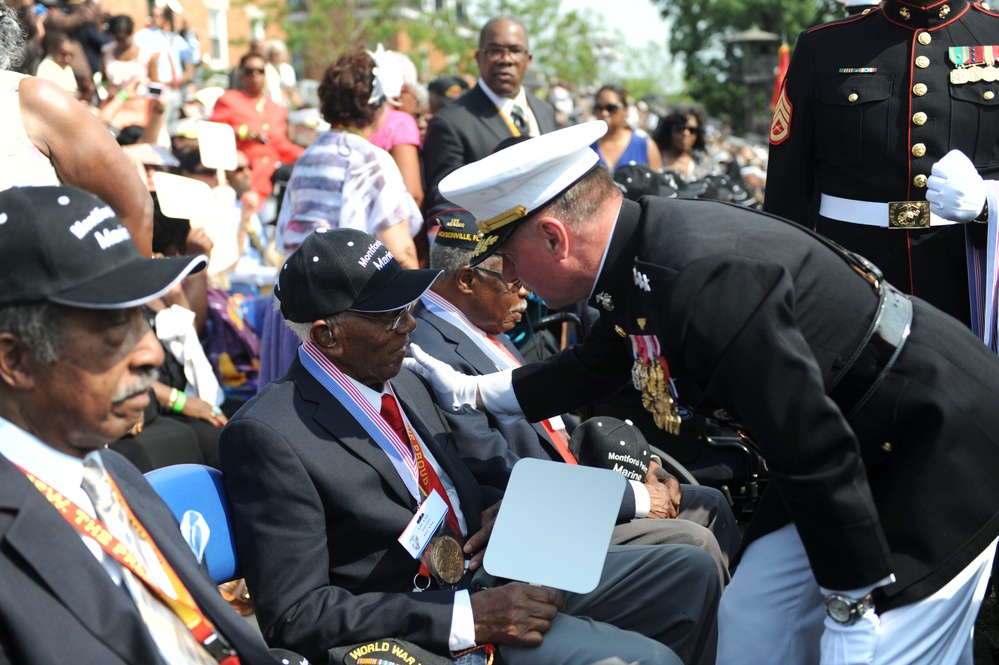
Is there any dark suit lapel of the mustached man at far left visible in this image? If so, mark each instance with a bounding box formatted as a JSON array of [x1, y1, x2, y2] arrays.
[[0, 457, 156, 662]]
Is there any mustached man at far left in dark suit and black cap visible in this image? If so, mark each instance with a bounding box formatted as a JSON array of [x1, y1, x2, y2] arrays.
[[0, 187, 290, 665]]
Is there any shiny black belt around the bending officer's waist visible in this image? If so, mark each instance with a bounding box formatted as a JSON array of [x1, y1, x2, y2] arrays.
[[827, 282, 912, 418]]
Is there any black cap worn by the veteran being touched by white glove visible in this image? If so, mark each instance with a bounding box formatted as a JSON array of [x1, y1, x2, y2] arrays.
[[274, 229, 440, 323]]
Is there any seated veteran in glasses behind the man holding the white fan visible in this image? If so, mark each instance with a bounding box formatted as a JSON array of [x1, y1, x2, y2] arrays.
[[411, 204, 739, 581]]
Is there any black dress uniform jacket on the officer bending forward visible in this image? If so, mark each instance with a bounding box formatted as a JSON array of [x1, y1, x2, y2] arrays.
[[514, 197, 999, 611]]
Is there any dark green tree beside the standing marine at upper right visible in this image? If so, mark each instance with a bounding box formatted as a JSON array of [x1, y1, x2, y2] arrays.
[[652, 0, 843, 130]]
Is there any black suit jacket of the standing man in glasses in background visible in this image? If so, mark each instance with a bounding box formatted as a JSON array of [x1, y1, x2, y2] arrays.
[[423, 86, 557, 209]]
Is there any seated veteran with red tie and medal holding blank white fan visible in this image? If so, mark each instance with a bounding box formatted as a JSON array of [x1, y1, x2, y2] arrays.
[[221, 229, 720, 665]]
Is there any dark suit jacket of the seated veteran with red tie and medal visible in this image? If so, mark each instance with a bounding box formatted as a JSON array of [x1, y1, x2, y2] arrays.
[[220, 358, 499, 663]]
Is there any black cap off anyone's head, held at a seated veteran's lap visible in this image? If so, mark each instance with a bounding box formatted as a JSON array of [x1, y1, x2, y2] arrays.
[[569, 416, 650, 481]]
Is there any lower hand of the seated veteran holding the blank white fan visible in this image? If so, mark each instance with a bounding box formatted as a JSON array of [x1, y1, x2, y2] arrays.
[[471, 583, 565, 647]]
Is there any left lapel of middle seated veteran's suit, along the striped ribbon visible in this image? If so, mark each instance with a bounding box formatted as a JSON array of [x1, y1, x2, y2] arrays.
[[290, 358, 424, 505]]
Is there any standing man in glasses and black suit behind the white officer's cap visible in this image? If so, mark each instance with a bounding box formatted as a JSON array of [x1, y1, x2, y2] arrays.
[[423, 16, 556, 209]]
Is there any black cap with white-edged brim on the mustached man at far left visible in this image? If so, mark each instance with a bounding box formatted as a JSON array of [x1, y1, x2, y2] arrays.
[[0, 187, 208, 309]]
